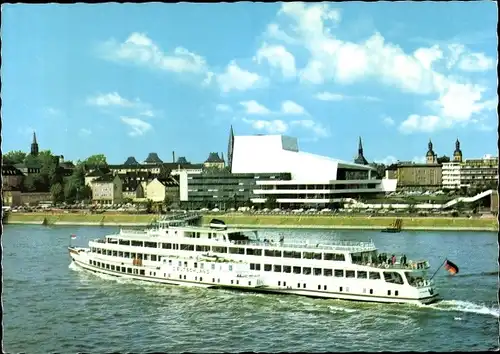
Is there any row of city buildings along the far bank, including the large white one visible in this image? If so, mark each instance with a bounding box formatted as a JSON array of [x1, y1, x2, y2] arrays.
[[2, 128, 498, 208]]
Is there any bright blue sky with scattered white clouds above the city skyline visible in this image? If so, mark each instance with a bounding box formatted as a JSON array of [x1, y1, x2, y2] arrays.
[[1, 2, 498, 163]]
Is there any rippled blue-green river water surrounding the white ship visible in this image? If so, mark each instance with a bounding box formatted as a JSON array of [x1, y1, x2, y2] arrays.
[[2, 225, 499, 353]]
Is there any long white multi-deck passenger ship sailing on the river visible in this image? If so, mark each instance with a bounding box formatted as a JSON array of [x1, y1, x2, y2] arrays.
[[69, 213, 438, 304]]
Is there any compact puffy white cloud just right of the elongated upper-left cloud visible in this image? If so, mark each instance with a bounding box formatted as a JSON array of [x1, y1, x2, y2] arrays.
[[217, 61, 266, 92]]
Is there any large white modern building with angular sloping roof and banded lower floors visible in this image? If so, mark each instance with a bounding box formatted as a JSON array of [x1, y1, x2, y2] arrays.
[[229, 134, 397, 206]]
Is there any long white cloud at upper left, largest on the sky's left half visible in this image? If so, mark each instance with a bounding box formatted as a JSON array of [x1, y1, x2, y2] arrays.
[[100, 32, 207, 74]]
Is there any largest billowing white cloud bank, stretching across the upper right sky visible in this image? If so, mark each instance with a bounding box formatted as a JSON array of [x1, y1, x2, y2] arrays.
[[272, 3, 498, 130]]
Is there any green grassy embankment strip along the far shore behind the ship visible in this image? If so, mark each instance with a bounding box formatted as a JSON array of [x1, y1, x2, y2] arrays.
[[4, 213, 498, 231]]
